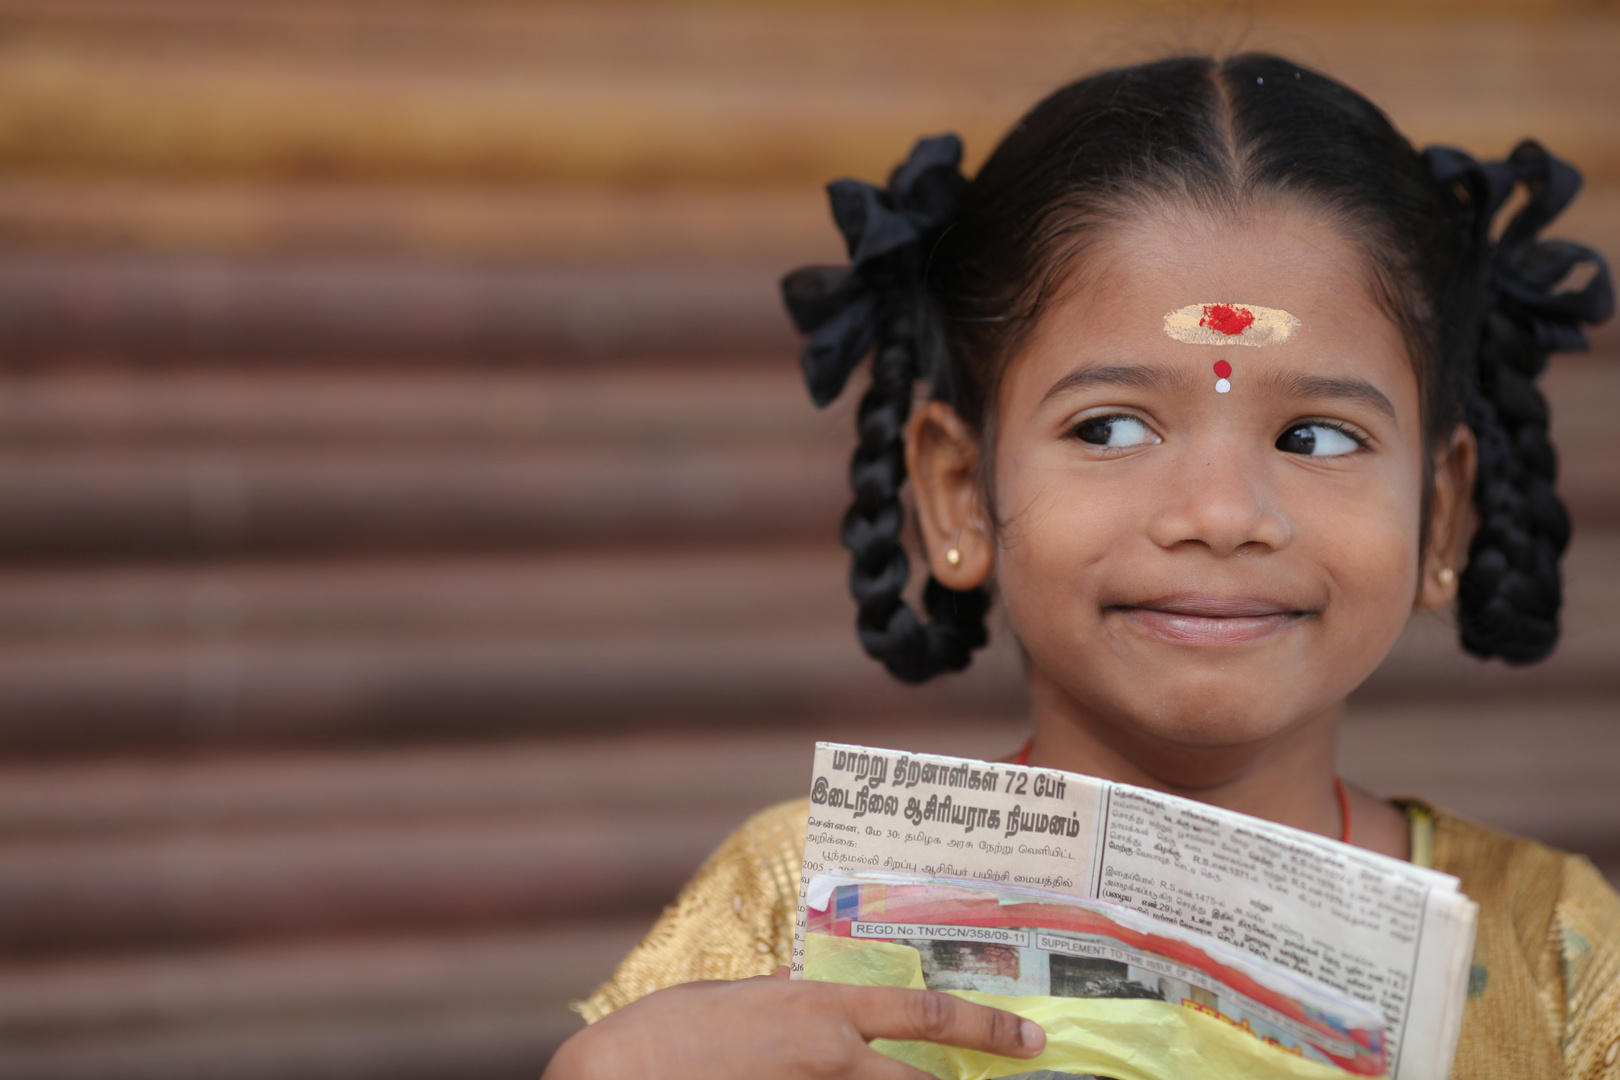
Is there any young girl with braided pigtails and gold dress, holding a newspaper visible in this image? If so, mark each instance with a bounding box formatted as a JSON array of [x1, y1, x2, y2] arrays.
[[548, 55, 1620, 1080]]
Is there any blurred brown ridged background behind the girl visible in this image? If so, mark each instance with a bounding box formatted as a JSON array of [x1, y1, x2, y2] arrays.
[[0, 0, 1620, 1080]]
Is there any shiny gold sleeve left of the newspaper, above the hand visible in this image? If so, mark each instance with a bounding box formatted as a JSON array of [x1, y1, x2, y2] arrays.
[[575, 798, 810, 1023]]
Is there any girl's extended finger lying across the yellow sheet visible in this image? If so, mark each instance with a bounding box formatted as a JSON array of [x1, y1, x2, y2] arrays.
[[851, 986, 1047, 1057]]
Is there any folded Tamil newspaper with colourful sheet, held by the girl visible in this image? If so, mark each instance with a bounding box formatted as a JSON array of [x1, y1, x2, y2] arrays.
[[794, 743, 1476, 1080]]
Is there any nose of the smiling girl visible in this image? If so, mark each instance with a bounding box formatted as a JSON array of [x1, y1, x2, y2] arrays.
[[1149, 460, 1293, 555]]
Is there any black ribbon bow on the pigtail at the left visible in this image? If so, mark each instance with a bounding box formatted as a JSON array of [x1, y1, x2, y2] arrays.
[[782, 134, 966, 405]]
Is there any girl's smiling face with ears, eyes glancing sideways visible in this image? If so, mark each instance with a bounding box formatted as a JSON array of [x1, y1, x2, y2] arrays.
[[914, 202, 1456, 785]]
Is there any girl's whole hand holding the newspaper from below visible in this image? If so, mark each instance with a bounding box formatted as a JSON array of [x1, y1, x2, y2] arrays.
[[541, 968, 1047, 1080]]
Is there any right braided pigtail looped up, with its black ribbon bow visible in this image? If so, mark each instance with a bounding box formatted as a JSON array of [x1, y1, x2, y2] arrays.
[[1424, 141, 1614, 664]]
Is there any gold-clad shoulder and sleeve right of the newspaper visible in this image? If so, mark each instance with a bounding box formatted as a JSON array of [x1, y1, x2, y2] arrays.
[[1425, 803, 1620, 1077]]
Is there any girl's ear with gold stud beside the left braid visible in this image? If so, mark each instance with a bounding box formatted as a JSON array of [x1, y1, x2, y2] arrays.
[[906, 402, 995, 593]]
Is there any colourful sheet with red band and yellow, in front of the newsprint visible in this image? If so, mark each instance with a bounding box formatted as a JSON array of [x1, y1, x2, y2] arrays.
[[805, 873, 1387, 1077]]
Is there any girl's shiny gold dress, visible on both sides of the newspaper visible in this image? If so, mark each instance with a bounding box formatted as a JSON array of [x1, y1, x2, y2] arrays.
[[578, 800, 1620, 1080]]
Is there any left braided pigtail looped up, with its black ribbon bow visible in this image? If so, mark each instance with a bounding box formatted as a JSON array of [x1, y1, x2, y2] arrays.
[[782, 136, 990, 683]]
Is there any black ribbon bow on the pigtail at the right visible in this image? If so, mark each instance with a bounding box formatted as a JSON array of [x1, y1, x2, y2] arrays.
[[1424, 139, 1615, 351]]
